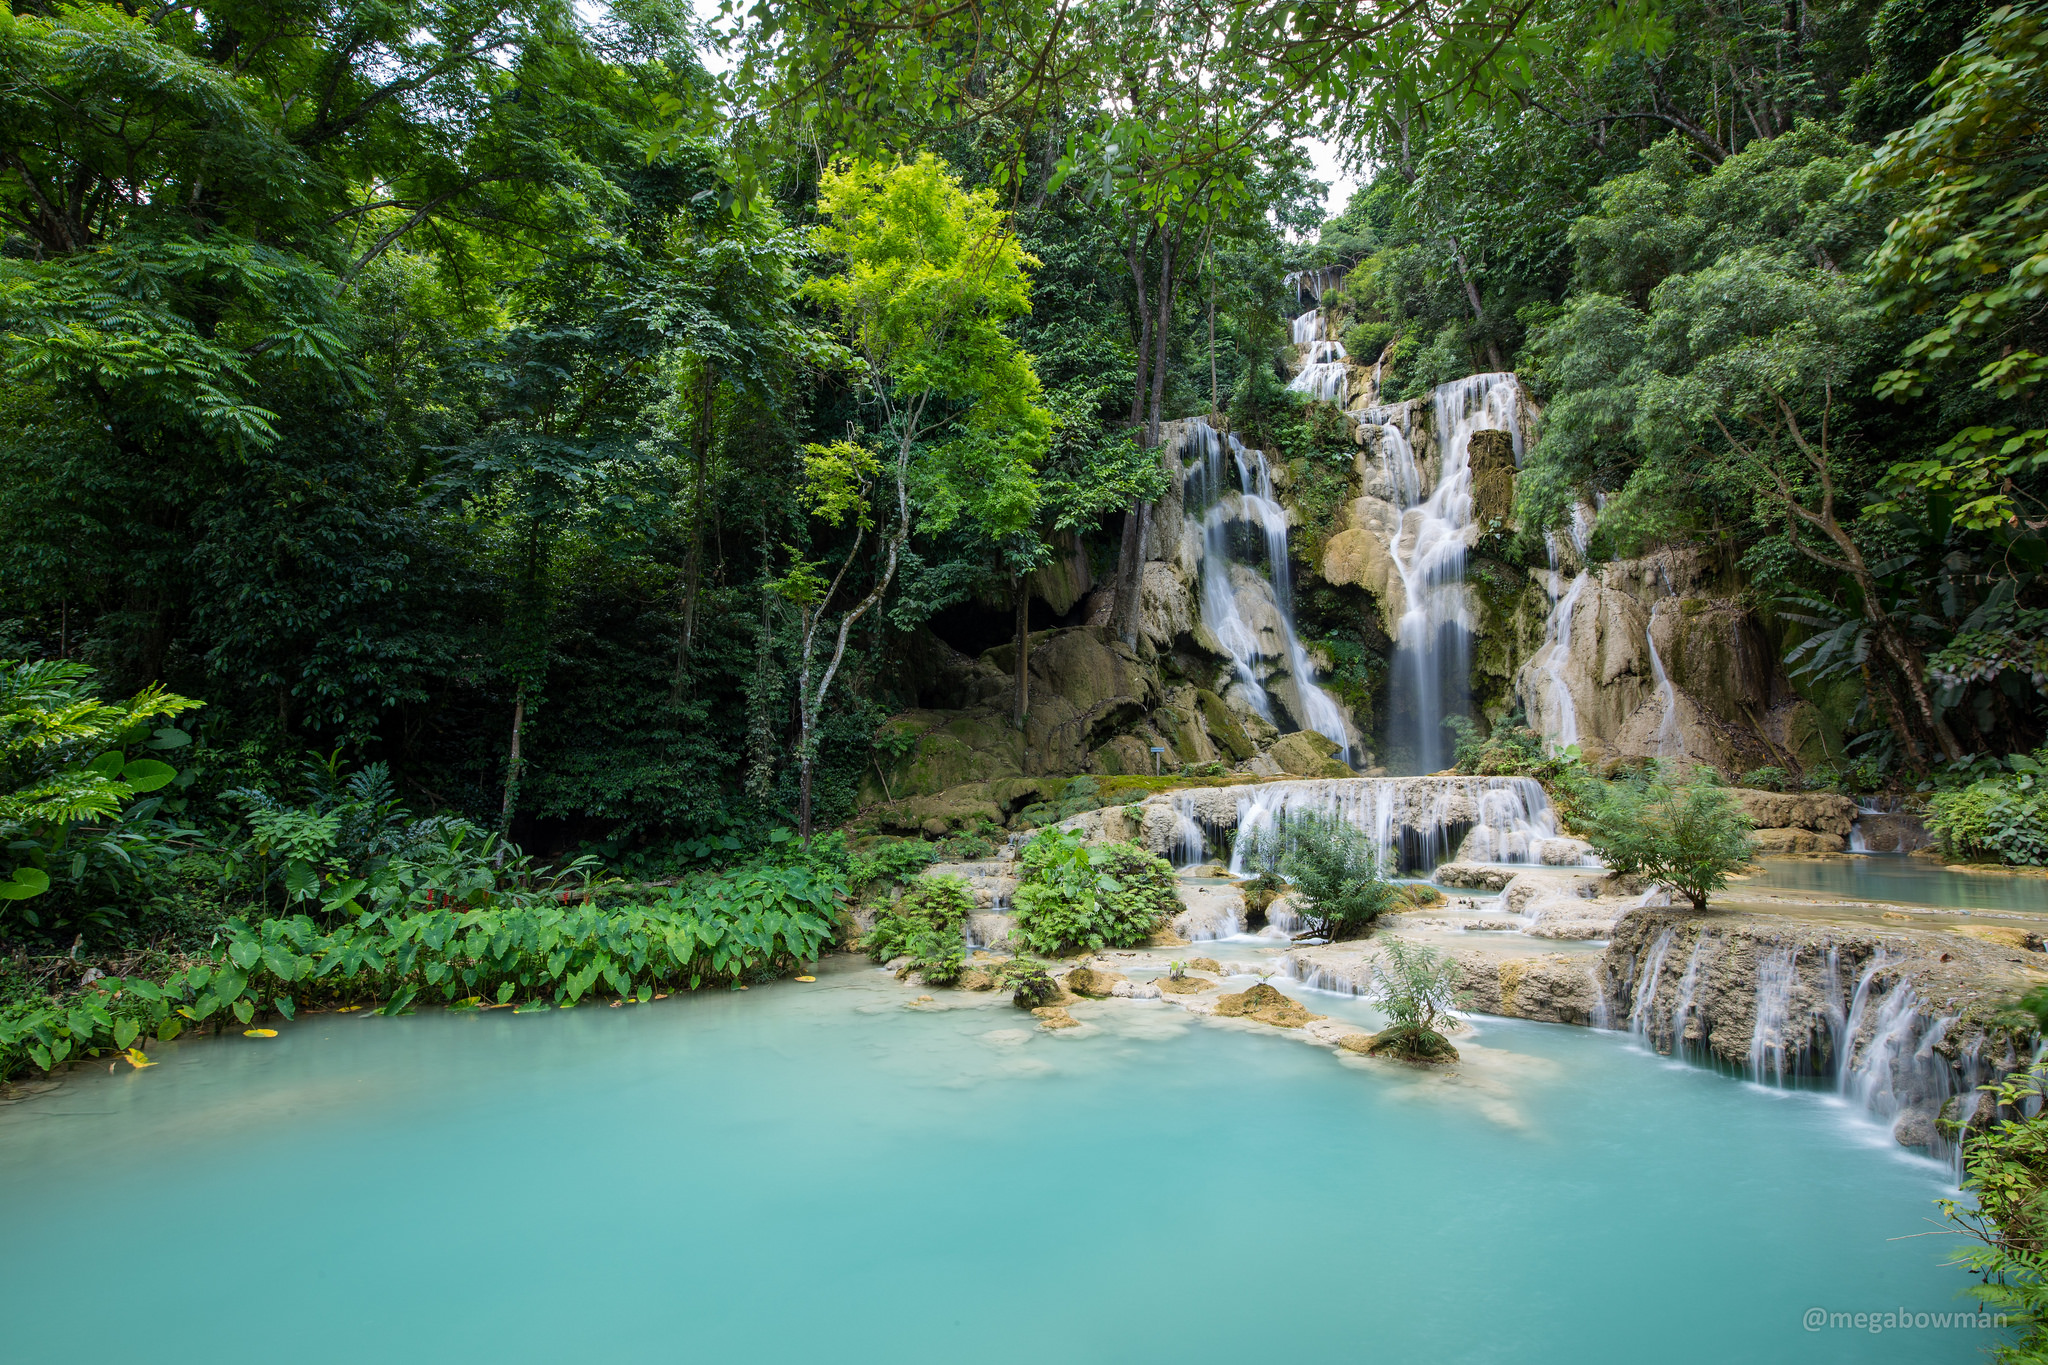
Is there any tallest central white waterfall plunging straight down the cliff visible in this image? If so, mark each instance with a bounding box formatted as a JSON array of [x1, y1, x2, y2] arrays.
[[1366, 372, 1522, 774]]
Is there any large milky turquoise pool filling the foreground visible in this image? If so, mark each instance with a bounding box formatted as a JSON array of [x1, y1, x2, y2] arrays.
[[0, 964, 1991, 1365]]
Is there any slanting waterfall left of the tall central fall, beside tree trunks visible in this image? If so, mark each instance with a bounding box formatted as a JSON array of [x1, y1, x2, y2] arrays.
[[1184, 417, 1352, 761]]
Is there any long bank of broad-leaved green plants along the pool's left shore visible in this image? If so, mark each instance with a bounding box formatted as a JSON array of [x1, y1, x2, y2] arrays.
[[0, 866, 846, 1078]]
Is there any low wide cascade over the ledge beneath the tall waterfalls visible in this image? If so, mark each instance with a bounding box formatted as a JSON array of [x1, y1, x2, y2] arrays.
[[1171, 778, 1581, 874]]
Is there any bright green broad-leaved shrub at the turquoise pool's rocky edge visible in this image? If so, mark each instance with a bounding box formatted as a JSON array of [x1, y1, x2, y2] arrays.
[[1016, 829, 1180, 956]]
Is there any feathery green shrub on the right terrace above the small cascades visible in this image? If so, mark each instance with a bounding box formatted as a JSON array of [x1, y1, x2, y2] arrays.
[[1577, 763, 1755, 911]]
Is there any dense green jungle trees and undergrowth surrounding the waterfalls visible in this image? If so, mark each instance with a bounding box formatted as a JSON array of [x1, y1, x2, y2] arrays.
[[0, 0, 2048, 1058]]
